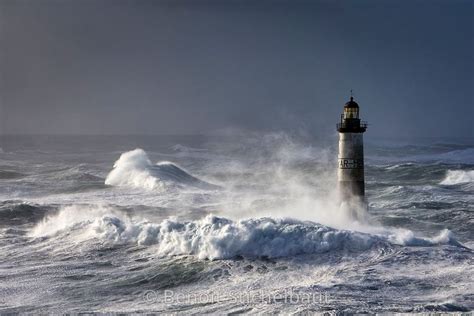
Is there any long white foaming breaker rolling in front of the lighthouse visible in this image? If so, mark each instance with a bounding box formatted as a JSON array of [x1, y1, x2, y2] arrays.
[[30, 206, 462, 260]]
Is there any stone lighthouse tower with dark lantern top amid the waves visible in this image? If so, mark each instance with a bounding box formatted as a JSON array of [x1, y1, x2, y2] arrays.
[[337, 91, 367, 200]]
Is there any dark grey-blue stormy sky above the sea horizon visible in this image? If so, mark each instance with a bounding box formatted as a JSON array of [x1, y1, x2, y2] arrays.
[[0, 0, 474, 137]]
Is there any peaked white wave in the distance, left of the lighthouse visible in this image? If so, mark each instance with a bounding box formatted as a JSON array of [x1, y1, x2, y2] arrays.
[[105, 148, 218, 190]]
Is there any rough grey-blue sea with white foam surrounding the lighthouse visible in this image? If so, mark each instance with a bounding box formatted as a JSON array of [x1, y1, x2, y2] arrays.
[[0, 133, 474, 314]]
